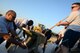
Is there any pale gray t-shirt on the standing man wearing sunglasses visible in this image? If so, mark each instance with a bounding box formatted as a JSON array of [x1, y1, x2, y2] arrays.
[[66, 11, 80, 32]]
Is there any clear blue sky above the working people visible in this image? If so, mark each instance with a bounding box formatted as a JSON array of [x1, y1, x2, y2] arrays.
[[0, 0, 80, 33]]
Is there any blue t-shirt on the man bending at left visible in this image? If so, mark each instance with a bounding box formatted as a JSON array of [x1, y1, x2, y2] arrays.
[[0, 16, 14, 33]]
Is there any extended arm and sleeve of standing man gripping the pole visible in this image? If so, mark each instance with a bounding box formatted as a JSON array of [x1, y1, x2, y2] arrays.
[[57, 11, 78, 26]]
